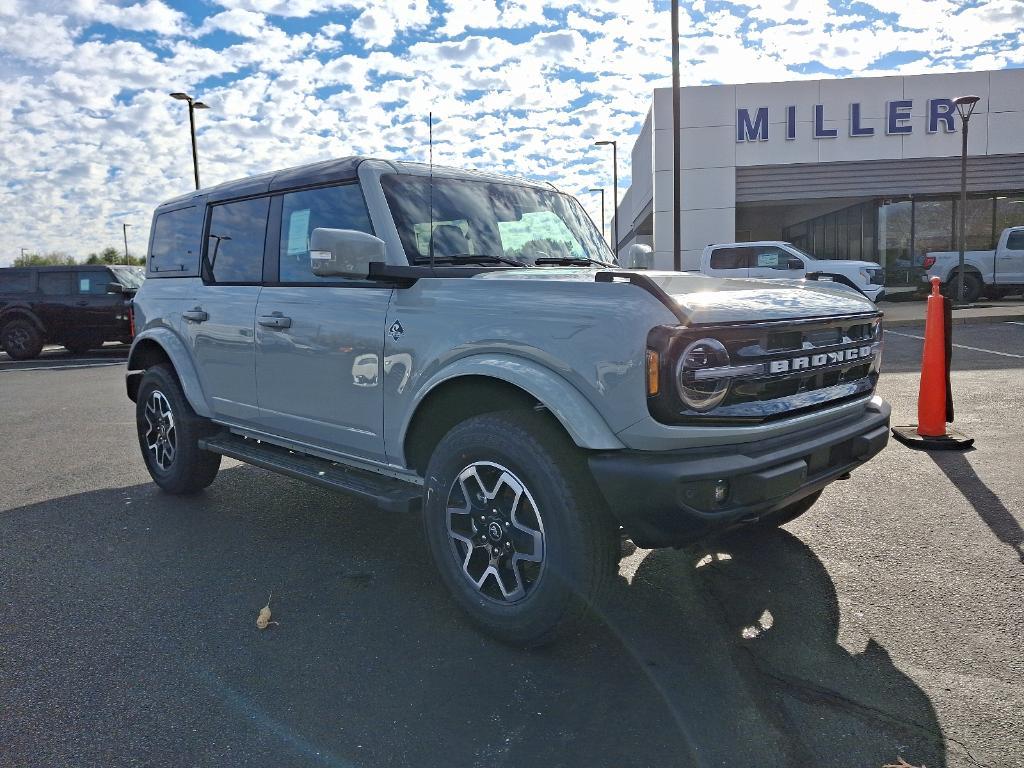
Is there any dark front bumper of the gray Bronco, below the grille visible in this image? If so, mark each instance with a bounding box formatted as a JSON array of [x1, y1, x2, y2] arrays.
[[589, 398, 891, 549]]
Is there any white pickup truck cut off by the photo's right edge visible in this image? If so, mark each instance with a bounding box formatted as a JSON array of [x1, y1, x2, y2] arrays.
[[922, 226, 1024, 301]]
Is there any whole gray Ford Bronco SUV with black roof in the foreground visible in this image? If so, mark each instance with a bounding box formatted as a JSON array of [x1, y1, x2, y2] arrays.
[[127, 158, 890, 645]]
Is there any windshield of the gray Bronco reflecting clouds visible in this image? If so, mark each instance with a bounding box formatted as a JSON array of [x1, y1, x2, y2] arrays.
[[381, 174, 614, 265]]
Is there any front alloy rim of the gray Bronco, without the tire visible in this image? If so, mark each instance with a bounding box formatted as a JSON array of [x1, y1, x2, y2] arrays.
[[446, 462, 545, 603]]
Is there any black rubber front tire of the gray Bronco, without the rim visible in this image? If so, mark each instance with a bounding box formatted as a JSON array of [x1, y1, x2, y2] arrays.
[[423, 411, 620, 647]]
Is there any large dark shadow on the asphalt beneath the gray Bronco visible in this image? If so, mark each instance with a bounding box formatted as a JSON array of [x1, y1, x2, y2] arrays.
[[0, 467, 945, 768]]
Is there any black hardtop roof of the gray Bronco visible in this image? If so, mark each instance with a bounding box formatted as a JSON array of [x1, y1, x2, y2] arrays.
[[153, 156, 554, 208]]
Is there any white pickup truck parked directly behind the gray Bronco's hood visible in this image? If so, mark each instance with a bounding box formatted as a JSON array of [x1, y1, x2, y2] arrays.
[[700, 240, 886, 301]]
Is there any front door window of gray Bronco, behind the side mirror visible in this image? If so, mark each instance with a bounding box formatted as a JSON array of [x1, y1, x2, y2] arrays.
[[280, 184, 374, 283]]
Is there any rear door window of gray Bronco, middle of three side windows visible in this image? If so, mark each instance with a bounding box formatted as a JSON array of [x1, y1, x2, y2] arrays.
[[206, 198, 270, 283]]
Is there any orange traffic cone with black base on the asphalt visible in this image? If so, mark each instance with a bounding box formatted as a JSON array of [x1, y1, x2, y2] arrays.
[[893, 278, 974, 451]]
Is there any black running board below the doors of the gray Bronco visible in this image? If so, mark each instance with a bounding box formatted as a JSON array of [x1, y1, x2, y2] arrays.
[[199, 434, 423, 512]]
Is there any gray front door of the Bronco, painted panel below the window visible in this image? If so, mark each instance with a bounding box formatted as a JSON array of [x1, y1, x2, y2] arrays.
[[256, 285, 392, 460]]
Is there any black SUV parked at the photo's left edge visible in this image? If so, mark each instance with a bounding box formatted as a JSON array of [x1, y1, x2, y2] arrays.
[[0, 265, 144, 360]]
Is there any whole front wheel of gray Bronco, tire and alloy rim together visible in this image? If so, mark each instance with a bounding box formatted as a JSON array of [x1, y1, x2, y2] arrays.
[[424, 412, 618, 647]]
